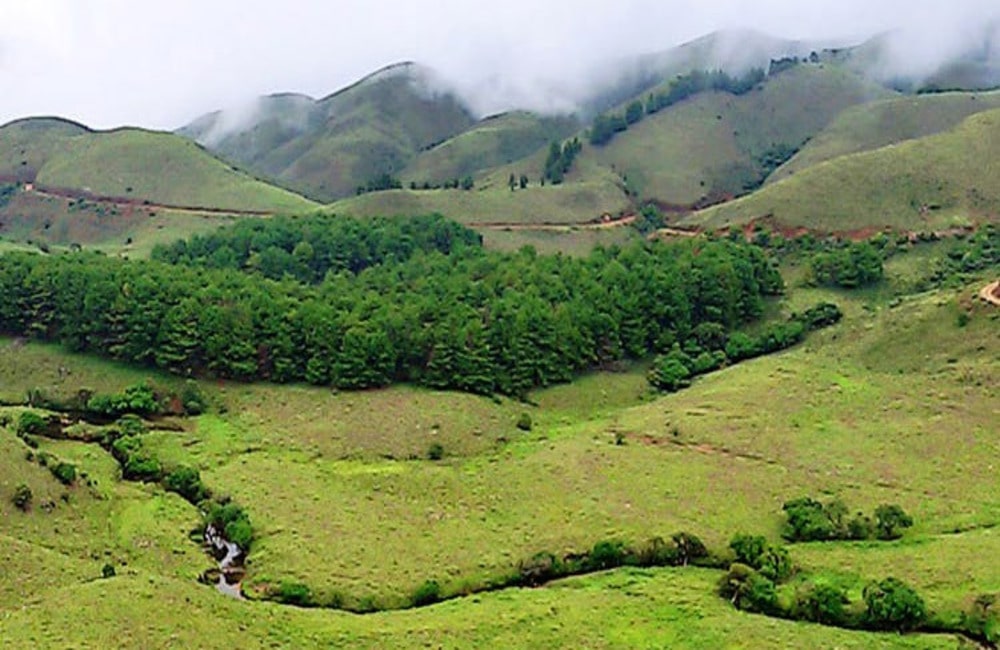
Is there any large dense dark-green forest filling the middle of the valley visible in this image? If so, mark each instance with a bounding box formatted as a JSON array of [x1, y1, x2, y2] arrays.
[[0, 219, 782, 396]]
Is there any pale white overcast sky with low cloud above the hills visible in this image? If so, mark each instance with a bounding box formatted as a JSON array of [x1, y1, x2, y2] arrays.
[[0, 0, 1000, 129]]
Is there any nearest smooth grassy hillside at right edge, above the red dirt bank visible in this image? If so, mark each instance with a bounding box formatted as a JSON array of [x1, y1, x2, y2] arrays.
[[686, 111, 1000, 231]]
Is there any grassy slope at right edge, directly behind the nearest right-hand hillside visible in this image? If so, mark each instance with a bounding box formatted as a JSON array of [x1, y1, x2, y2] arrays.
[[768, 87, 1000, 183]]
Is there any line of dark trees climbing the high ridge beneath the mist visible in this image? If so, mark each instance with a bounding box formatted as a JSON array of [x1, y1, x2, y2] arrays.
[[590, 68, 767, 146]]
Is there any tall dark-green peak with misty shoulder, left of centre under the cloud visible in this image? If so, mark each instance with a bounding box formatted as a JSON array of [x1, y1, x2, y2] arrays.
[[179, 64, 475, 201]]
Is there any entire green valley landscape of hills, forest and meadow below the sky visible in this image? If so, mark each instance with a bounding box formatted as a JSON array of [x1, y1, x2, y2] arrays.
[[0, 17, 1000, 650]]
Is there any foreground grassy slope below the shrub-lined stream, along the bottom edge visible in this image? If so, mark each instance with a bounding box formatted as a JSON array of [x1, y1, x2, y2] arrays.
[[0, 570, 954, 650]]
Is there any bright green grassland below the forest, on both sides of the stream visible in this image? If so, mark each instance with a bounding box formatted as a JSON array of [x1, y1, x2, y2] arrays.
[[0, 240, 1000, 648]]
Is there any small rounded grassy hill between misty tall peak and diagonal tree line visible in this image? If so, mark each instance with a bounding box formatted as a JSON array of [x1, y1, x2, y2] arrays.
[[400, 111, 579, 185]]
